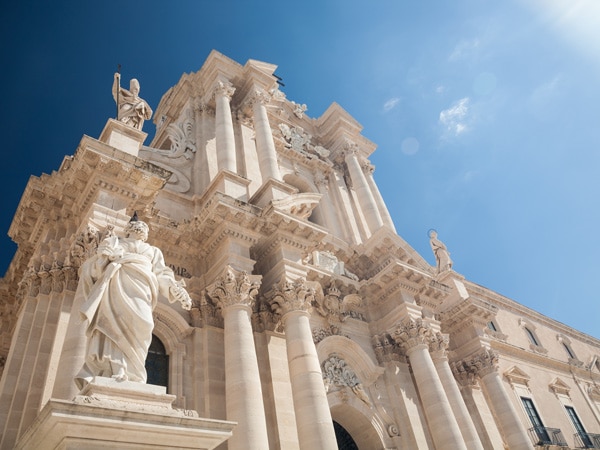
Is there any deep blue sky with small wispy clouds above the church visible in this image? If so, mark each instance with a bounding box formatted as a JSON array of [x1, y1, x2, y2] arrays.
[[0, 0, 600, 337]]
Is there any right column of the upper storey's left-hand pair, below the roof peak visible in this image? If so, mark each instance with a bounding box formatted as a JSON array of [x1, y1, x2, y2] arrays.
[[250, 90, 282, 183]]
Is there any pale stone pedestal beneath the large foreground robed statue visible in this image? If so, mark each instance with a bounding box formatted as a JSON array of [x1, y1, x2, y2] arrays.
[[15, 377, 235, 450]]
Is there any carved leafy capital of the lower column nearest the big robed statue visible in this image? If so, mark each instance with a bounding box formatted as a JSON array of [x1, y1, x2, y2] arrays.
[[207, 266, 261, 309]]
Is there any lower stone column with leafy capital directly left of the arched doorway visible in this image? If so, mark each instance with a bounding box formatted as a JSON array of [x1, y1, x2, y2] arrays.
[[270, 278, 337, 450]]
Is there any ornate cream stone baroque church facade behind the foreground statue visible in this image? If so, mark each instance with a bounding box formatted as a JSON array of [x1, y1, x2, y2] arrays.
[[0, 51, 600, 450]]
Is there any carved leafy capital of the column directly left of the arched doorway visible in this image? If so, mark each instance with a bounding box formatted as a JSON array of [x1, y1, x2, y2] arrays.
[[269, 276, 317, 316]]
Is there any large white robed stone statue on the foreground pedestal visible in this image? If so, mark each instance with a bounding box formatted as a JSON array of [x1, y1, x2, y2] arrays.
[[75, 214, 192, 389]]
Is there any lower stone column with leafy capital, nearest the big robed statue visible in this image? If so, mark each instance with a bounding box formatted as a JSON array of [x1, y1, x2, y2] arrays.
[[207, 266, 269, 450]]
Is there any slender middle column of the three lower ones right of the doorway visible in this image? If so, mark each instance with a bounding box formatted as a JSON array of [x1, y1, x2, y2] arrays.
[[430, 333, 483, 450]]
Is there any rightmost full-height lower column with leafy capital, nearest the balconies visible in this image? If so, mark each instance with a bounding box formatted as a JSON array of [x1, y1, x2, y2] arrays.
[[471, 350, 533, 450]]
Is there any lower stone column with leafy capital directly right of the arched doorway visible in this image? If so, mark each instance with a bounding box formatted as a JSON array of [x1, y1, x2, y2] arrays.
[[391, 319, 467, 450]]
